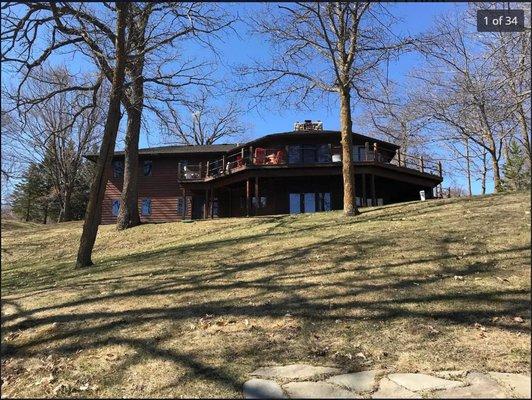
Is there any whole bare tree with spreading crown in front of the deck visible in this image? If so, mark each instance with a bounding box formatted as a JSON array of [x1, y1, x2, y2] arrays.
[[241, 2, 412, 216]]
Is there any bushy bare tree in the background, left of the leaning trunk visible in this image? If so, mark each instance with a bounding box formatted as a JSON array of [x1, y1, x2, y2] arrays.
[[4, 67, 103, 222]]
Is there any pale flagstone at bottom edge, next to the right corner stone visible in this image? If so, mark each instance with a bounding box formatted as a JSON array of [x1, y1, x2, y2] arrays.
[[432, 372, 509, 399]]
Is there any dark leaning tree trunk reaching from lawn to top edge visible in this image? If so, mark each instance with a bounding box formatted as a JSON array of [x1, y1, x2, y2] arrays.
[[76, 2, 129, 267]]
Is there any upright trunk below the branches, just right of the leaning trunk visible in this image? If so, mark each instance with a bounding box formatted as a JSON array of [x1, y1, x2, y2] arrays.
[[116, 99, 142, 229]]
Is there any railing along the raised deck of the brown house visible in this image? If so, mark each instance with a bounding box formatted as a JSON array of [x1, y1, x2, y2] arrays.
[[178, 143, 442, 181]]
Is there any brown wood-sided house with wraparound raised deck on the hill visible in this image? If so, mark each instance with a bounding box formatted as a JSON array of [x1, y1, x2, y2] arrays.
[[87, 121, 443, 224]]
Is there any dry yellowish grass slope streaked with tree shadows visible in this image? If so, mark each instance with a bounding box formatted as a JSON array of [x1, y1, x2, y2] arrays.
[[1, 193, 531, 397]]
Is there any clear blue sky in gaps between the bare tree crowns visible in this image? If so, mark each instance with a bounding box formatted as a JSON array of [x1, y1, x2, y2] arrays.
[[2, 3, 488, 193]]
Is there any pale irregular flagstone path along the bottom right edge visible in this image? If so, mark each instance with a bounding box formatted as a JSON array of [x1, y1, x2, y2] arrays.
[[243, 364, 530, 399]]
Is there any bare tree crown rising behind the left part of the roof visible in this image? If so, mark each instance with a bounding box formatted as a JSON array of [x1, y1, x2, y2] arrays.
[[159, 91, 245, 145]]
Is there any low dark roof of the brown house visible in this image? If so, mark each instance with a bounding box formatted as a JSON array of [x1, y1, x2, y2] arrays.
[[85, 131, 400, 161]]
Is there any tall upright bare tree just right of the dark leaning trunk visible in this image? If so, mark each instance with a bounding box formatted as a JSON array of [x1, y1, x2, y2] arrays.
[[117, 2, 233, 229]]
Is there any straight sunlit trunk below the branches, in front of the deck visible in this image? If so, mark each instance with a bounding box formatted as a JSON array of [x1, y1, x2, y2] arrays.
[[340, 88, 359, 216]]
